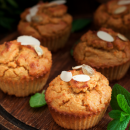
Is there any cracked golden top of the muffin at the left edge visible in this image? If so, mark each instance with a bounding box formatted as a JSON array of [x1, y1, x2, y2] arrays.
[[0, 40, 52, 80]]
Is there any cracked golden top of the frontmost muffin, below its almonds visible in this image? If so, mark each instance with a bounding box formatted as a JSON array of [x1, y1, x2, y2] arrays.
[[45, 69, 111, 116]]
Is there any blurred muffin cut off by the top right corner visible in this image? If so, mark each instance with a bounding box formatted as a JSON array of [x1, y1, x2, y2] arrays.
[[94, 0, 130, 39]]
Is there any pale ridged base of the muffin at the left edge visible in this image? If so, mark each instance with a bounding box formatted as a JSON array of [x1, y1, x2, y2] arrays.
[[0, 72, 50, 97]]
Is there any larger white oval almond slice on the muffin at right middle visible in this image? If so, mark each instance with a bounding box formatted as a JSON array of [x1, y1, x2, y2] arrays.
[[97, 31, 114, 42]]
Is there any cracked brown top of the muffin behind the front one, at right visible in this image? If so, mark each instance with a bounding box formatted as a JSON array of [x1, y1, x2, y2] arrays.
[[74, 28, 130, 68]]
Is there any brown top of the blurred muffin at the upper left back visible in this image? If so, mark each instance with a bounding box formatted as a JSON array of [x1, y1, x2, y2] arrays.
[[18, 3, 72, 39]]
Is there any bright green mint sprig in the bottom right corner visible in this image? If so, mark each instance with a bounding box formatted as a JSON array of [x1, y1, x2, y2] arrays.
[[107, 84, 130, 130]]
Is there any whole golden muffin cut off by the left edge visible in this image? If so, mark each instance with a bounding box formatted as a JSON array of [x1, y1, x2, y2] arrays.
[[0, 36, 52, 97]]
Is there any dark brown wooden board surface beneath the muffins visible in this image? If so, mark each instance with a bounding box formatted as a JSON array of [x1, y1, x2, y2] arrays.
[[0, 0, 130, 130]]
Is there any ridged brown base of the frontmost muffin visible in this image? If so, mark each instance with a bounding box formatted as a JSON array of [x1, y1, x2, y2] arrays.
[[49, 106, 108, 130]]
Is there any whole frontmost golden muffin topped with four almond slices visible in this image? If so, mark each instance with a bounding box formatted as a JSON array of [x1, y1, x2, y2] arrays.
[[45, 65, 112, 130]]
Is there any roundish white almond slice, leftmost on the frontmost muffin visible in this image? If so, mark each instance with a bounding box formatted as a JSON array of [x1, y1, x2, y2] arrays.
[[60, 71, 72, 82]]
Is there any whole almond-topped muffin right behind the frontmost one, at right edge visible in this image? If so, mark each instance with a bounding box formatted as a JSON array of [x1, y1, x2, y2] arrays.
[[73, 28, 130, 81]]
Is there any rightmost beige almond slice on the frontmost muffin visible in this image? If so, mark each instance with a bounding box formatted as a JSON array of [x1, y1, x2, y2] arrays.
[[82, 64, 95, 76]]
